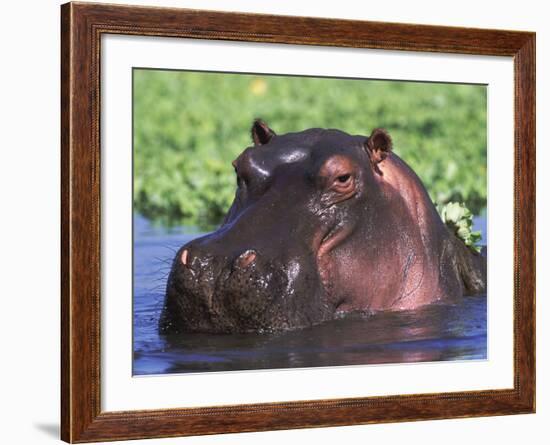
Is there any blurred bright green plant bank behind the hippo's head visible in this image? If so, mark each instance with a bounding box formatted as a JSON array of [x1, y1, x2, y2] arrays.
[[134, 69, 487, 229]]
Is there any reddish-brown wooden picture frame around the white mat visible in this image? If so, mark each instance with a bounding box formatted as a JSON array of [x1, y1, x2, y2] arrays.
[[61, 3, 535, 443]]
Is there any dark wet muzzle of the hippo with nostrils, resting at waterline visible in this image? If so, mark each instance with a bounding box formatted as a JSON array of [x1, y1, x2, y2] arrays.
[[160, 236, 332, 333]]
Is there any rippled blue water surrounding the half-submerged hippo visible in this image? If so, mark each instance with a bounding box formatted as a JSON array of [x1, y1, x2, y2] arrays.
[[133, 216, 487, 375]]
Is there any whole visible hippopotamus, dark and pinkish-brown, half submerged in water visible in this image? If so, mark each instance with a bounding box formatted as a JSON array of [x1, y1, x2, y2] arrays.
[[159, 119, 486, 334]]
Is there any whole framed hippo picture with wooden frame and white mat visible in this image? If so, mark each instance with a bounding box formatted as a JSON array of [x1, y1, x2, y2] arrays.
[[61, 3, 535, 443]]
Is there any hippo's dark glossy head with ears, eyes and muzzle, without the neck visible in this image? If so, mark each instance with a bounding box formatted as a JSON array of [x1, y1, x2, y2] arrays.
[[159, 120, 391, 333]]
